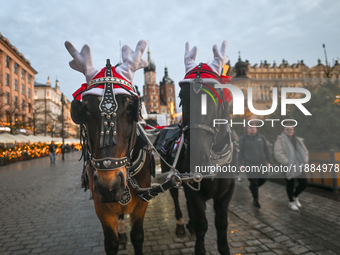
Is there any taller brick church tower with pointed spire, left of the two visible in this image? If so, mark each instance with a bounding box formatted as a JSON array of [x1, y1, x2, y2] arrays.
[[143, 50, 160, 113]]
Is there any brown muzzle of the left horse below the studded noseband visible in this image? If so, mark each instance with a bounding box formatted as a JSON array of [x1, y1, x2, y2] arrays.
[[93, 167, 126, 203]]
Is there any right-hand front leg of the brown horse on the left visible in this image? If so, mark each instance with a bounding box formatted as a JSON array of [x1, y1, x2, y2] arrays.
[[130, 201, 148, 255]]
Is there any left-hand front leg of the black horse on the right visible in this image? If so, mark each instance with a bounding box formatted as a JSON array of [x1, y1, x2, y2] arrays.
[[185, 187, 208, 255]]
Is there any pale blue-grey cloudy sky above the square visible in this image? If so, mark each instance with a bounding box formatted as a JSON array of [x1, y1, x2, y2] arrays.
[[0, 0, 340, 104]]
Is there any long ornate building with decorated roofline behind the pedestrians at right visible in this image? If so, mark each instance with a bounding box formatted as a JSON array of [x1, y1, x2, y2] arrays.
[[228, 56, 340, 117]]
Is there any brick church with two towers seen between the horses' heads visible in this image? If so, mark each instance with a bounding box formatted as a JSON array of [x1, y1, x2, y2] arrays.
[[143, 51, 176, 124]]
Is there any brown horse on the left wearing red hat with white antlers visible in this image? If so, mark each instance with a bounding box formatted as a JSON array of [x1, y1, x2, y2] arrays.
[[65, 41, 153, 254]]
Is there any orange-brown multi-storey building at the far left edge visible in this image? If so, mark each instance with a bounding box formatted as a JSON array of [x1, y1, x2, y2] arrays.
[[0, 34, 37, 134]]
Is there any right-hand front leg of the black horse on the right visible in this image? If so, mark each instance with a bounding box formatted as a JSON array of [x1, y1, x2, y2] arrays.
[[214, 182, 235, 255]]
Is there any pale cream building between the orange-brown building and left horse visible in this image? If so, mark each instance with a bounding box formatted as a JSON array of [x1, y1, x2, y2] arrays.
[[34, 78, 79, 138]]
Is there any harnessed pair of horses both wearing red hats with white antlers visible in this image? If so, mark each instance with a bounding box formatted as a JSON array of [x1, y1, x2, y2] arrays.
[[65, 40, 235, 254]]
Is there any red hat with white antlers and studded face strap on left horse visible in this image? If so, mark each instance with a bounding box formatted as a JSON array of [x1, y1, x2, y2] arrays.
[[65, 40, 148, 147]]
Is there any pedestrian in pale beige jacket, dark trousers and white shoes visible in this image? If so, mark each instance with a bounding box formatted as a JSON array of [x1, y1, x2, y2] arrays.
[[274, 127, 309, 211]]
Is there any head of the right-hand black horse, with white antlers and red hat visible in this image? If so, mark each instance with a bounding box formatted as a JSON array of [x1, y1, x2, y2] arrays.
[[179, 41, 230, 172]]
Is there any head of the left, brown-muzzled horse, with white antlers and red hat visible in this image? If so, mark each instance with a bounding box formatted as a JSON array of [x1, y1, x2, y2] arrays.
[[65, 40, 148, 203]]
